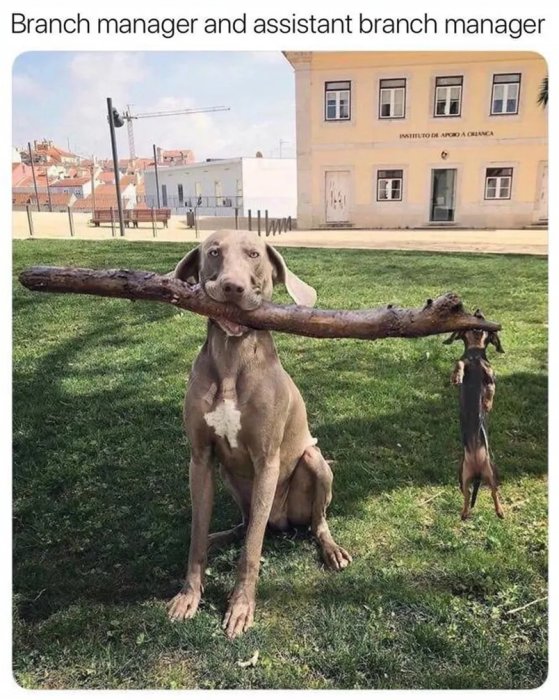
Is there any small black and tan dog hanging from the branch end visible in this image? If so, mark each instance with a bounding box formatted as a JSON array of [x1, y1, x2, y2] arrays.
[[443, 309, 505, 520]]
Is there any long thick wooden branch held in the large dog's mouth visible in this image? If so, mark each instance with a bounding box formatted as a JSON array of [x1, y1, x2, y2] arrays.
[[19, 267, 501, 340]]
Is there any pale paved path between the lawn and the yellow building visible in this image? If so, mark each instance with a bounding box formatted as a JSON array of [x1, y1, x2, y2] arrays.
[[12, 212, 548, 255]]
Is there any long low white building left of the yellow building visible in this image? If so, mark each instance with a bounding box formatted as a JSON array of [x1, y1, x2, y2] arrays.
[[145, 158, 297, 217]]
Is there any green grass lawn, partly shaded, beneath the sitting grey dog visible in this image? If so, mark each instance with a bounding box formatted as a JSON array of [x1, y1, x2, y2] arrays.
[[10, 241, 547, 688]]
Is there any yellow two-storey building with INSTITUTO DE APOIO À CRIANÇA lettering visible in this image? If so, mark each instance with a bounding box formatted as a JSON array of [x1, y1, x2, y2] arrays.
[[285, 51, 547, 228]]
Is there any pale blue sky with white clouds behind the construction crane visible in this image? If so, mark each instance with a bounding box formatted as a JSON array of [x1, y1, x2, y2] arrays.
[[12, 51, 295, 160]]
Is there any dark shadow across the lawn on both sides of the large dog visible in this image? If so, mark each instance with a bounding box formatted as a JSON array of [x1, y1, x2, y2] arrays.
[[14, 309, 547, 618]]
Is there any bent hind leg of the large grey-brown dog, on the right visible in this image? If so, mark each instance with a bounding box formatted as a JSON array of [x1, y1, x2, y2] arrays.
[[288, 446, 351, 571]]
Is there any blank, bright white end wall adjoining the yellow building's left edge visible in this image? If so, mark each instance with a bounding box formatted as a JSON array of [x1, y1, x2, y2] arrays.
[[243, 158, 297, 217]]
